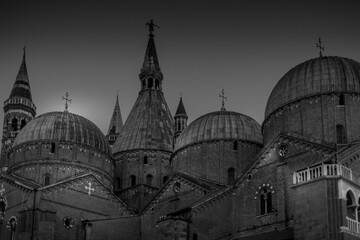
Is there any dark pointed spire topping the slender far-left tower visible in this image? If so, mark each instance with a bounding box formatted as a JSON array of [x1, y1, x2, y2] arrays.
[[10, 47, 32, 100]]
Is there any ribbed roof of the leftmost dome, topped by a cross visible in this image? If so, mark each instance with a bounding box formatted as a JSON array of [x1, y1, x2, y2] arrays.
[[13, 112, 110, 154]]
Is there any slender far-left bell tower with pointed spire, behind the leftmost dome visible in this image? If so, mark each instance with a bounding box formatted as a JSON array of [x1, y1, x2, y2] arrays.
[[1, 47, 36, 166]]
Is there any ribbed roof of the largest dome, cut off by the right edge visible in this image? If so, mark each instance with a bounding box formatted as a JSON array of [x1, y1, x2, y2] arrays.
[[265, 57, 360, 119]]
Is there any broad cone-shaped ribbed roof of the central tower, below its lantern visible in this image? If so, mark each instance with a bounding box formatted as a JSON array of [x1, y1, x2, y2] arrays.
[[113, 89, 174, 153]]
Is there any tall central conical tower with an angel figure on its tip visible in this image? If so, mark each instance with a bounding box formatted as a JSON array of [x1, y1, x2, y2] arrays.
[[113, 20, 174, 210]]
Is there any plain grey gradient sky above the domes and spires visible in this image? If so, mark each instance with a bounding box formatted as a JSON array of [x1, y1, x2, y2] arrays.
[[0, 0, 360, 137]]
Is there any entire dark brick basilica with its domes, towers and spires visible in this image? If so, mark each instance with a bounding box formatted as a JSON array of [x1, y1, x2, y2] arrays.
[[0, 21, 360, 240]]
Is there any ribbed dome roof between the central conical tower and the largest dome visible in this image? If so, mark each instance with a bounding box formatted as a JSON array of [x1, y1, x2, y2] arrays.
[[175, 111, 263, 150]]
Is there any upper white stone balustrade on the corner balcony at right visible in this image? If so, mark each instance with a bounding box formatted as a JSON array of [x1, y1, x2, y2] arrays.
[[293, 164, 360, 185]]
